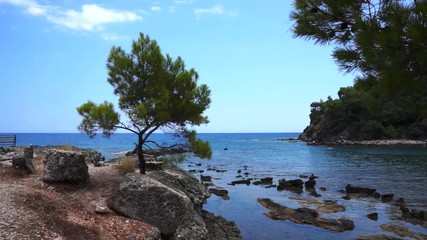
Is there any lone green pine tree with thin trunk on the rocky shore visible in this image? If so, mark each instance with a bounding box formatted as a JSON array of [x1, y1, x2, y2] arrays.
[[77, 33, 212, 174]]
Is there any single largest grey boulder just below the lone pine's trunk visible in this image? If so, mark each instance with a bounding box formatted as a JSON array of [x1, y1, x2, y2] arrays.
[[108, 172, 208, 239]]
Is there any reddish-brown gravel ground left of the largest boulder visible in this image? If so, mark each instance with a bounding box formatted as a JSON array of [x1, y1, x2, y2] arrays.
[[0, 156, 160, 240]]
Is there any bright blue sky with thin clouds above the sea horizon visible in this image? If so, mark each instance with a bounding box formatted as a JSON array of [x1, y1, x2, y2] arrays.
[[0, 0, 353, 133]]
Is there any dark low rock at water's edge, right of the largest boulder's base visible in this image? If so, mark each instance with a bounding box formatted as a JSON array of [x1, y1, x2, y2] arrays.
[[202, 210, 242, 240]]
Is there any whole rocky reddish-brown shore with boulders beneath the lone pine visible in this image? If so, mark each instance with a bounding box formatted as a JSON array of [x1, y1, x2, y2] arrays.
[[0, 146, 242, 240]]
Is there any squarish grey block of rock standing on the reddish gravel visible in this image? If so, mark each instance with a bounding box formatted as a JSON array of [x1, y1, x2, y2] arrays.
[[43, 150, 89, 183]]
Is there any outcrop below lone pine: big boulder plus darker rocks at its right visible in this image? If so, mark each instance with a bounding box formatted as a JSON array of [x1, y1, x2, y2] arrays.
[[108, 166, 240, 239]]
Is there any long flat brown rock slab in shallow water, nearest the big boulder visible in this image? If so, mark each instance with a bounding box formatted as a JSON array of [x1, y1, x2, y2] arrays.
[[258, 198, 354, 232]]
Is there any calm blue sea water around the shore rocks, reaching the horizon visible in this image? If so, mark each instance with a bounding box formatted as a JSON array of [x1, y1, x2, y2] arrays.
[[11, 133, 427, 240]]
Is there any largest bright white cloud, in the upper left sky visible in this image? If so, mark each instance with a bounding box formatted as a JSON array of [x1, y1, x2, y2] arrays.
[[0, 0, 142, 31]]
